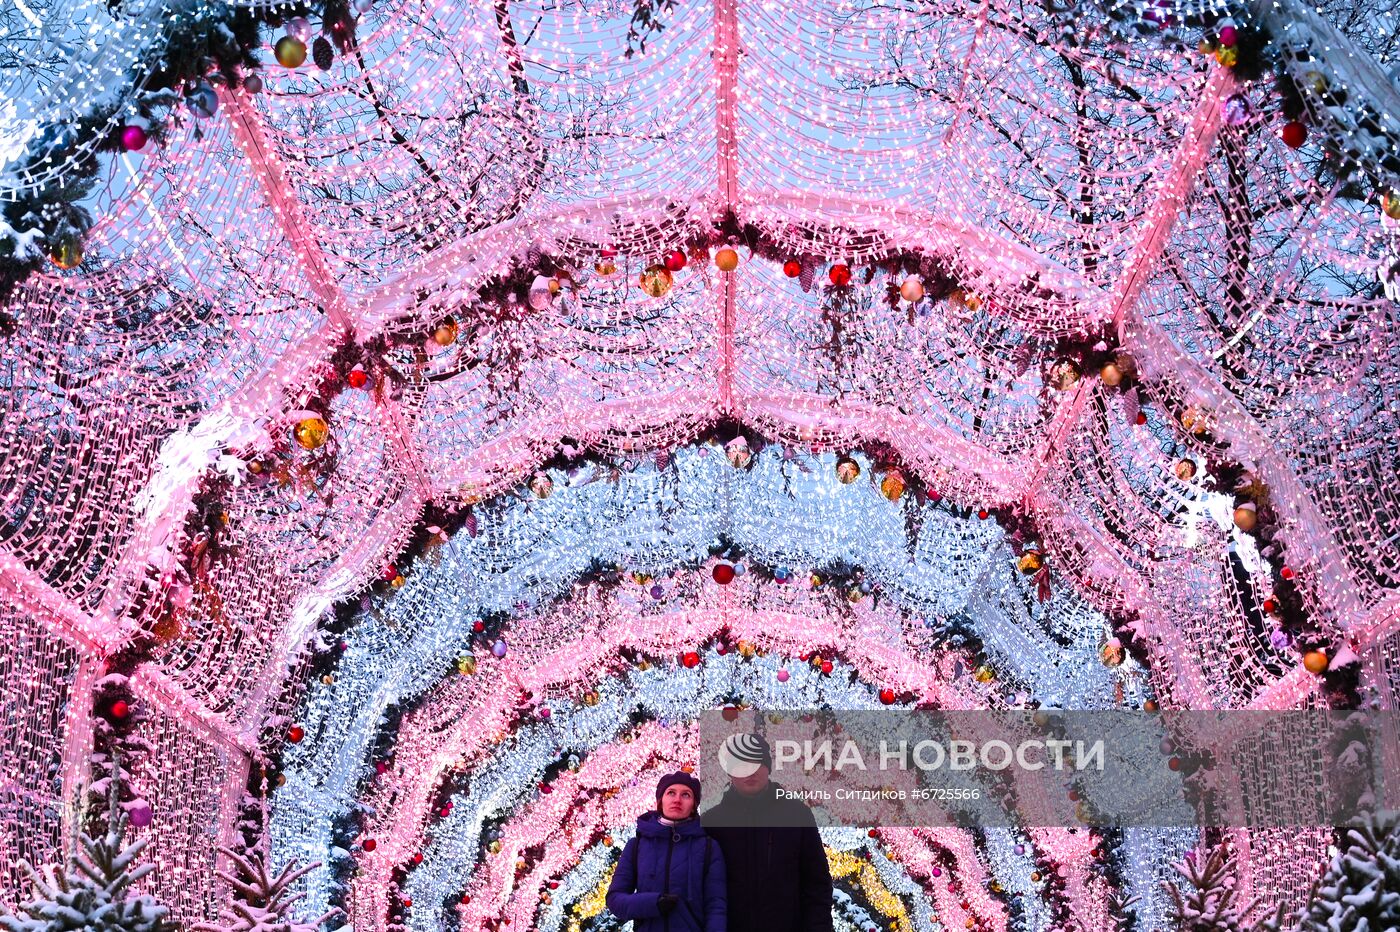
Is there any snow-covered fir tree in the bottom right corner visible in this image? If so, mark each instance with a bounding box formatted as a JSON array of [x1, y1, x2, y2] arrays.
[[1298, 810, 1400, 932]]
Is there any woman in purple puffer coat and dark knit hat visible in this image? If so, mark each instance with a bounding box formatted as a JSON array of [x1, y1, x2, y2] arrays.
[[608, 771, 727, 932]]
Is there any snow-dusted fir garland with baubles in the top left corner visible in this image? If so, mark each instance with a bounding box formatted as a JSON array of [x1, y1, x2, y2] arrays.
[[0, 0, 372, 302]]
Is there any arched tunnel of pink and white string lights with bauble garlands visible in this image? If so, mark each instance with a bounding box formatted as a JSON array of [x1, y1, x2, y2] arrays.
[[0, 0, 1400, 932]]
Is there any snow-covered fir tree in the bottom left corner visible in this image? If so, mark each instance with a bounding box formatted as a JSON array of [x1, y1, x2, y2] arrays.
[[0, 761, 171, 932]]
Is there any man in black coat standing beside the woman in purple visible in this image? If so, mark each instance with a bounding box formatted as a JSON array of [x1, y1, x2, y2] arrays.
[[701, 735, 832, 932]]
